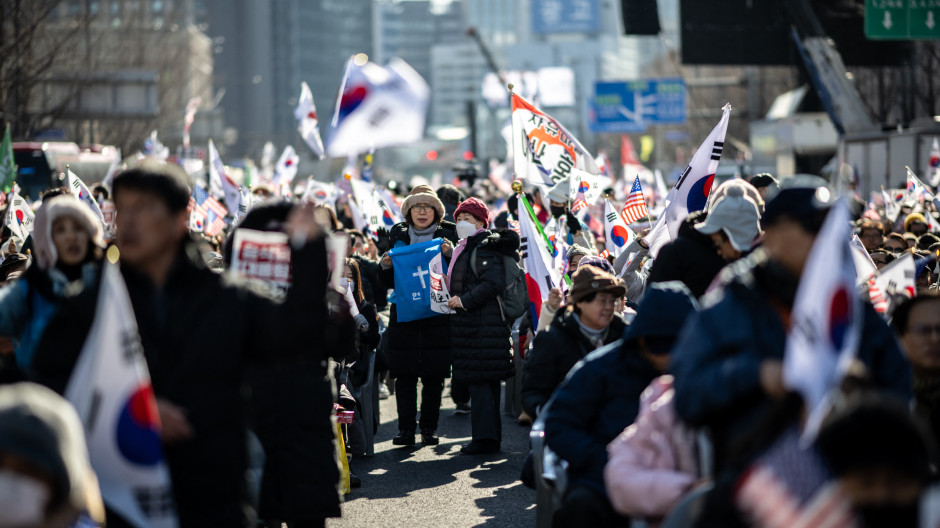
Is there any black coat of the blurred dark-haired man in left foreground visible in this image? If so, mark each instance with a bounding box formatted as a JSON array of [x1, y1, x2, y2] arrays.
[[121, 239, 339, 528]]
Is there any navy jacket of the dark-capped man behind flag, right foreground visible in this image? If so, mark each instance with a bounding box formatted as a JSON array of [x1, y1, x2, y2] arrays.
[[670, 251, 912, 470]]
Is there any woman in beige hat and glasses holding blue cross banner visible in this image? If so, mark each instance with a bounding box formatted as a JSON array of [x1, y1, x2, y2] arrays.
[[379, 185, 457, 446]]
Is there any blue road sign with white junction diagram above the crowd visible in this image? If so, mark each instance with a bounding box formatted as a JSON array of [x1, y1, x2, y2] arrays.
[[589, 79, 685, 133]]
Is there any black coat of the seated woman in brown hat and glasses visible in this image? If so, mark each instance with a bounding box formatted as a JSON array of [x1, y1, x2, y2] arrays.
[[522, 309, 627, 416]]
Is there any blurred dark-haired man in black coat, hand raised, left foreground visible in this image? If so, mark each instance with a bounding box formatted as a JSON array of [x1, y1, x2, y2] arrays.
[[112, 162, 339, 528]]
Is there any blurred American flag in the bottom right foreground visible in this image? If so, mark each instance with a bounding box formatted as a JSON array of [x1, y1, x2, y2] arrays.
[[735, 428, 856, 528]]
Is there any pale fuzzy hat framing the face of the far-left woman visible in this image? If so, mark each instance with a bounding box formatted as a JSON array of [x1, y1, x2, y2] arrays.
[[33, 194, 104, 270]]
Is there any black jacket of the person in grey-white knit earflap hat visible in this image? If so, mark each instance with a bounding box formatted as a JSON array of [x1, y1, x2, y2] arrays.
[[646, 211, 726, 298]]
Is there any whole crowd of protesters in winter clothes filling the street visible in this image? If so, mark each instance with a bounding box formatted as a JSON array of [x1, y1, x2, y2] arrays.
[[0, 161, 940, 528]]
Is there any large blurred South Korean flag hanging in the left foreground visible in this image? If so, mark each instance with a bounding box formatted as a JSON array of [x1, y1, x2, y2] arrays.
[[65, 262, 178, 528]]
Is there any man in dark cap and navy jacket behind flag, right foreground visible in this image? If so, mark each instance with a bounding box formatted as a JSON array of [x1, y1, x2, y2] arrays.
[[671, 187, 911, 526]]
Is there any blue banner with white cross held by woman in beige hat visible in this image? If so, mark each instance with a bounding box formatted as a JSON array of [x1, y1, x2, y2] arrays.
[[388, 238, 446, 323]]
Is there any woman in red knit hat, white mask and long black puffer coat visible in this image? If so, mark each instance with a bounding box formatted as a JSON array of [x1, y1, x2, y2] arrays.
[[447, 198, 519, 454]]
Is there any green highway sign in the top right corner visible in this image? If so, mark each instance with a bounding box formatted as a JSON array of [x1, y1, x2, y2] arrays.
[[865, 0, 940, 40]]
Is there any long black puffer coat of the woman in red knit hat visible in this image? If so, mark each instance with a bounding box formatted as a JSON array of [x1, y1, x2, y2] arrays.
[[450, 229, 519, 383]]
